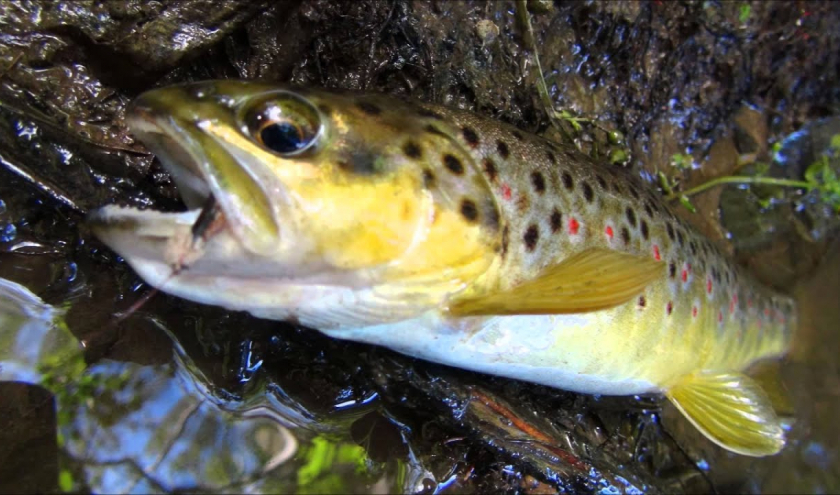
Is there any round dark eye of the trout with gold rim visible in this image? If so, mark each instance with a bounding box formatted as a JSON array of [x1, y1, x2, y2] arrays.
[[243, 94, 321, 156]]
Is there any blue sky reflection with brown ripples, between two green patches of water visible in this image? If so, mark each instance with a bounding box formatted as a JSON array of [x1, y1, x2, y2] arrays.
[[59, 361, 298, 493]]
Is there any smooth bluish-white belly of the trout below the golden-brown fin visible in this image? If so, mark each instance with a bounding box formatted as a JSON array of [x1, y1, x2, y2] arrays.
[[324, 311, 659, 395]]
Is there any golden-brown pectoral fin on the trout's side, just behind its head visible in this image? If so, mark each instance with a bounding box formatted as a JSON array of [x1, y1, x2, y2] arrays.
[[449, 249, 665, 316]]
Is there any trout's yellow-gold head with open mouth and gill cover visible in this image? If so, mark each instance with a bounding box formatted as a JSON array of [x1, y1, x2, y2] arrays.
[[90, 81, 501, 320]]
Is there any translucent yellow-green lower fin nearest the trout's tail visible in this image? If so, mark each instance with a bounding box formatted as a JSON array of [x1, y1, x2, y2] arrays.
[[666, 373, 785, 457]]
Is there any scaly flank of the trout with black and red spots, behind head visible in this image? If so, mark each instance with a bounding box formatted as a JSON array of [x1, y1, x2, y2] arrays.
[[416, 102, 793, 375]]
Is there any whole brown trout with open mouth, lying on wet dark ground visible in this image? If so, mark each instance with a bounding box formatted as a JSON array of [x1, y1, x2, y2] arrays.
[[88, 80, 797, 456]]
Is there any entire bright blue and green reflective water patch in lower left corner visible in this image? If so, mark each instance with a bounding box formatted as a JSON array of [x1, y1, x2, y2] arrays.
[[0, 279, 408, 493]]
